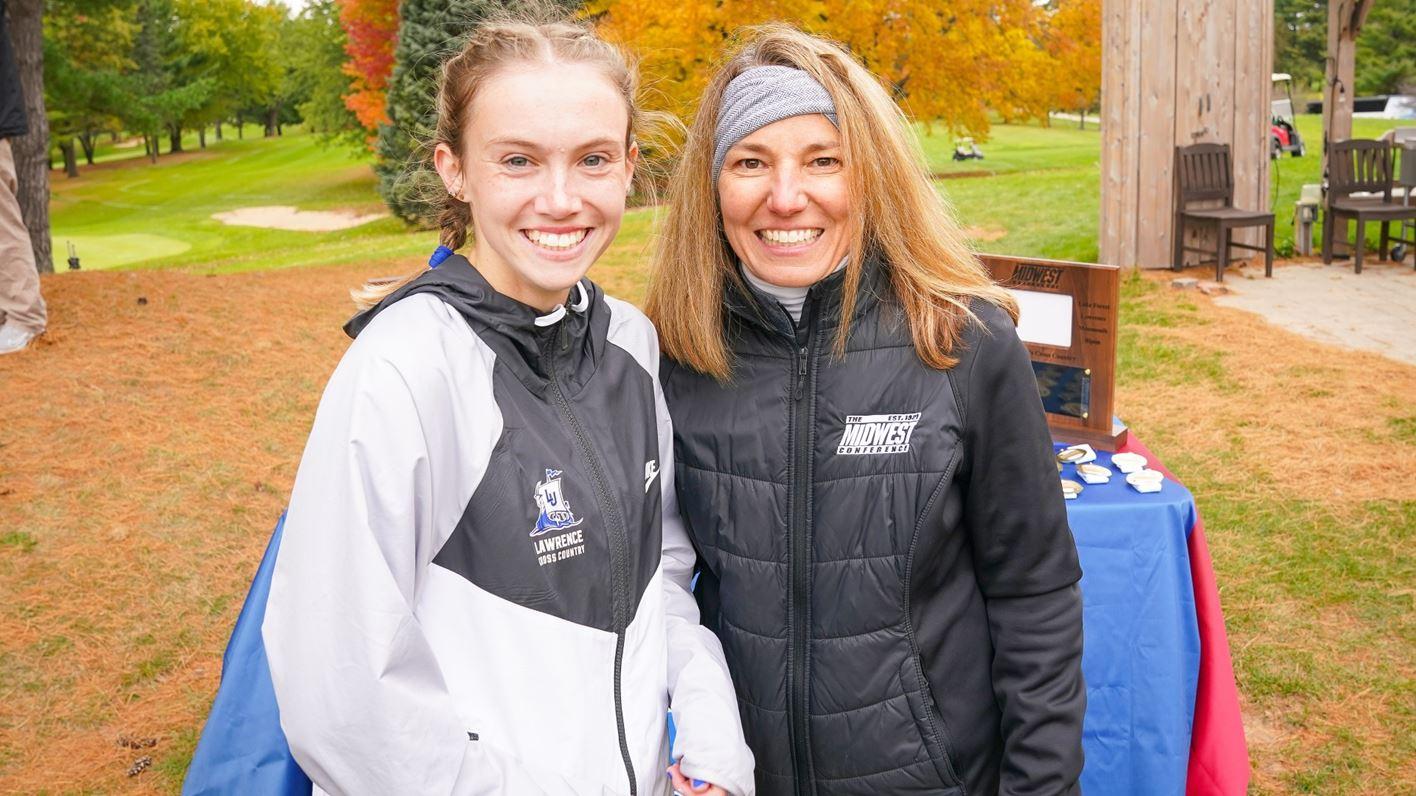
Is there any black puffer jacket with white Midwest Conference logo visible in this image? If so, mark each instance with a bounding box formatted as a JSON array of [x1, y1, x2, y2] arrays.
[[663, 257, 1086, 796]]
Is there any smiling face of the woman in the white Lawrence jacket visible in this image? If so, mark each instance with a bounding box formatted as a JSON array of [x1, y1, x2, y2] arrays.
[[433, 64, 639, 312]]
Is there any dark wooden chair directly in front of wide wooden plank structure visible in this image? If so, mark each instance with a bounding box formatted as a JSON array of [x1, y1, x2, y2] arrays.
[[1170, 143, 1273, 282]]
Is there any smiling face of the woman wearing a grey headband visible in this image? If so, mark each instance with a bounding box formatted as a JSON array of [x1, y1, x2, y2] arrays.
[[718, 113, 851, 288]]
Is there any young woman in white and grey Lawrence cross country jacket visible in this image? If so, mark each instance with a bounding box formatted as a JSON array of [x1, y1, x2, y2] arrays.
[[263, 13, 753, 796]]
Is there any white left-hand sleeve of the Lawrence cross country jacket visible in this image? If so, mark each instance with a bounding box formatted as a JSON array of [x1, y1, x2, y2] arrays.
[[262, 331, 599, 793]]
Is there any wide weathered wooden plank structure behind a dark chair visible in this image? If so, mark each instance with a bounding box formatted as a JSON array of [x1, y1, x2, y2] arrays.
[[1099, 0, 1273, 268]]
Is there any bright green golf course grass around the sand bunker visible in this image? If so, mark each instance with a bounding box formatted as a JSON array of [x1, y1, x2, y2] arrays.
[[51, 123, 436, 272]]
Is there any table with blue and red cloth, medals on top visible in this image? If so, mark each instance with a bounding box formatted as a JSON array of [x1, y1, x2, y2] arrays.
[[1056, 433, 1249, 796]]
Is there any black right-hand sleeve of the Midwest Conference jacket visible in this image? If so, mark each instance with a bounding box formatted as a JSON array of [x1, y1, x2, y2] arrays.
[[963, 300, 1086, 796]]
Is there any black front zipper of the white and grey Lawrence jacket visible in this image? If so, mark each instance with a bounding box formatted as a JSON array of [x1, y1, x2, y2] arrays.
[[542, 322, 639, 796]]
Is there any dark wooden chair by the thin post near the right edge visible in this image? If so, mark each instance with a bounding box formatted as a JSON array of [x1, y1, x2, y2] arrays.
[[1323, 139, 1416, 273]]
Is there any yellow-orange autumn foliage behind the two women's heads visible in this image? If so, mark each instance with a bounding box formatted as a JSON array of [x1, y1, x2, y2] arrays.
[[586, 0, 1056, 135]]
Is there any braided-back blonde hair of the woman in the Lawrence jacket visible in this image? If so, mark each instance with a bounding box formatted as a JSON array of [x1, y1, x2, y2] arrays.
[[350, 10, 663, 309]]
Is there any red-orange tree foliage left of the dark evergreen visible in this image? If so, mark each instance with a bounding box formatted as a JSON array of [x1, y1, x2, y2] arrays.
[[338, 0, 398, 133]]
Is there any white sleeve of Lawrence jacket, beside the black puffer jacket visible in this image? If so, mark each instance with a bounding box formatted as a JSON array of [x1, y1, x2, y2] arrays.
[[654, 368, 756, 796]]
